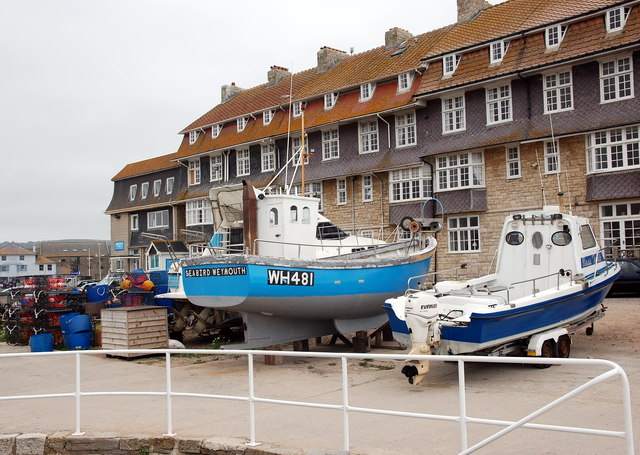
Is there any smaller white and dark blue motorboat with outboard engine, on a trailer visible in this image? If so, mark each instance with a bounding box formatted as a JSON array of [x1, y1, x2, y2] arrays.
[[385, 207, 619, 383]]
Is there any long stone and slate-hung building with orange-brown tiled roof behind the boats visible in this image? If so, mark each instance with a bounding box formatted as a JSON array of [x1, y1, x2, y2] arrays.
[[107, 0, 640, 269]]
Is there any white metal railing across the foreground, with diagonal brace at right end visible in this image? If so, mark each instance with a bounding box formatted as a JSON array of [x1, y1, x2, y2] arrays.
[[0, 349, 634, 455]]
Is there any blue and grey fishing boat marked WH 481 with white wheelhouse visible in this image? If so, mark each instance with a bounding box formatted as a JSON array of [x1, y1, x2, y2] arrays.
[[181, 182, 436, 348]]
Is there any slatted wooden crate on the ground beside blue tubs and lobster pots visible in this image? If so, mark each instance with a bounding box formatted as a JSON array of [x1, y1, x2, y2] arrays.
[[100, 306, 169, 357]]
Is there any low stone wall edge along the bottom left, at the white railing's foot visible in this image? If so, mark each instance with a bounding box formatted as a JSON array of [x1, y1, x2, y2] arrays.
[[0, 432, 346, 455]]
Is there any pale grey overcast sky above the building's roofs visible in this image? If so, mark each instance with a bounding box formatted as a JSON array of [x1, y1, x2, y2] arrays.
[[0, 0, 500, 242]]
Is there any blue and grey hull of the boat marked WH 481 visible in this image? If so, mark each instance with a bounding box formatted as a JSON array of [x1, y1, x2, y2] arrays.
[[183, 254, 431, 319]]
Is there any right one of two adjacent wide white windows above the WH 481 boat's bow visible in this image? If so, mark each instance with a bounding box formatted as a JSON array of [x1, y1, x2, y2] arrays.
[[436, 152, 485, 191]]
